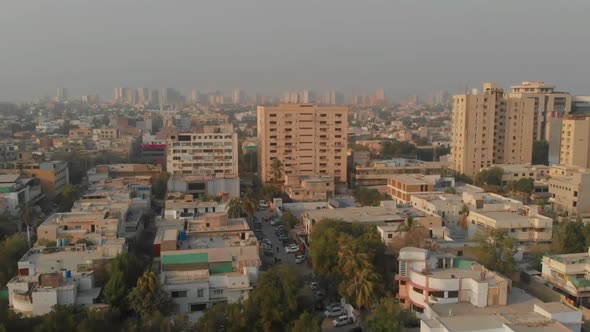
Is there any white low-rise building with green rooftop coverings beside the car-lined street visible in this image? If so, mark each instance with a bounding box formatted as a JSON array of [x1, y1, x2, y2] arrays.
[[154, 212, 261, 320]]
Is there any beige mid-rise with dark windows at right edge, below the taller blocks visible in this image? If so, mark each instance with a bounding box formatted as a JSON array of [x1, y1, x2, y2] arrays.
[[549, 165, 590, 218]]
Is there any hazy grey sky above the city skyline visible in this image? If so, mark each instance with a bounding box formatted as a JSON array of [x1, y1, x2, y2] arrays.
[[0, 0, 590, 101]]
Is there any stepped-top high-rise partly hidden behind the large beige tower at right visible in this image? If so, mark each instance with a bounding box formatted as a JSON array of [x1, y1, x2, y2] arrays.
[[511, 81, 572, 141]]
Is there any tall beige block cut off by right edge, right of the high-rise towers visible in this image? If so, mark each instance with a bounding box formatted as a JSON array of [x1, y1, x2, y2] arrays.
[[559, 116, 590, 168]]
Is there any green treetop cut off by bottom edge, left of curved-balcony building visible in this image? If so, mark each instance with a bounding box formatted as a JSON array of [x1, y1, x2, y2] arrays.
[[366, 298, 420, 332]]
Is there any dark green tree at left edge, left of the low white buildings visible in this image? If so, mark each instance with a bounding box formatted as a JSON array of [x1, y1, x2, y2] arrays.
[[0, 233, 29, 288]]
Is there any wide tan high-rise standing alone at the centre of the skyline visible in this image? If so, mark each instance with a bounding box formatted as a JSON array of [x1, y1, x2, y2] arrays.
[[257, 104, 348, 182]]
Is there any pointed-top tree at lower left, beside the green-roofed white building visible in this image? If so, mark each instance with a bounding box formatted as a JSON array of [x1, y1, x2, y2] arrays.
[[127, 270, 174, 317]]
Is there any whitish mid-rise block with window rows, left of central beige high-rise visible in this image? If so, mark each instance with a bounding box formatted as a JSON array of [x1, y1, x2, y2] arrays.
[[166, 124, 238, 178]]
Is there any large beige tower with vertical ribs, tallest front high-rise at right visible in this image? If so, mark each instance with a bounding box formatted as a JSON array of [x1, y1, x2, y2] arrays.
[[451, 83, 535, 176]]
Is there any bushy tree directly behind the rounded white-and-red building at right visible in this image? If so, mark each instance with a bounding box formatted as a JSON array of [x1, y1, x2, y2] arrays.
[[475, 229, 518, 274]]
